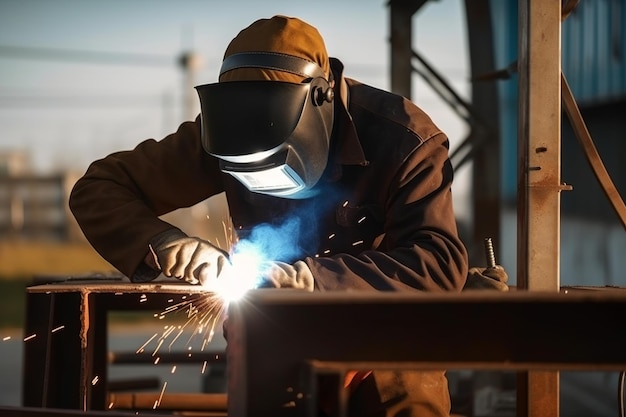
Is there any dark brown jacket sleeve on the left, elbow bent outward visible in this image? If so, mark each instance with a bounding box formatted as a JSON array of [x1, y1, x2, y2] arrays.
[[69, 118, 222, 279]]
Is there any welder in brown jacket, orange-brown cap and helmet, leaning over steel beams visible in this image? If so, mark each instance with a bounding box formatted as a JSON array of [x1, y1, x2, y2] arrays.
[[70, 16, 502, 416]]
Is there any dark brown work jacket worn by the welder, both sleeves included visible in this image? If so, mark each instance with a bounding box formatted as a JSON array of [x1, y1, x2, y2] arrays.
[[69, 58, 467, 291]]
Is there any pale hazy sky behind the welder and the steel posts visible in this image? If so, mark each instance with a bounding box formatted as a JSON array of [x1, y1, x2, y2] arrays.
[[0, 0, 469, 211]]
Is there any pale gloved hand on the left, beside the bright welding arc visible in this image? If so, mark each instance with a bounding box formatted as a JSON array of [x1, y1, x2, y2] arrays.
[[150, 229, 229, 284]]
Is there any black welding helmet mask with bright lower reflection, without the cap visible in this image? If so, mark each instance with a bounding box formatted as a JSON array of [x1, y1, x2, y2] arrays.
[[196, 78, 333, 198]]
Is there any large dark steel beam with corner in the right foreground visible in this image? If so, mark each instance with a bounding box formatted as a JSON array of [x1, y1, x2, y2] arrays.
[[227, 290, 626, 417]]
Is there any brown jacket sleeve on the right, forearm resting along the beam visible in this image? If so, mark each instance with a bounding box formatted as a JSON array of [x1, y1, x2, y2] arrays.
[[306, 133, 468, 291]]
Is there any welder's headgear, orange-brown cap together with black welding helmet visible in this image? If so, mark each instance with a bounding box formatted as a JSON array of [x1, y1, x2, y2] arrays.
[[196, 15, 333, 198]]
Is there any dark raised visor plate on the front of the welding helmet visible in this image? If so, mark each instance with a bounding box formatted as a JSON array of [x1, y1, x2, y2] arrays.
[[196, 81, 310, 158]]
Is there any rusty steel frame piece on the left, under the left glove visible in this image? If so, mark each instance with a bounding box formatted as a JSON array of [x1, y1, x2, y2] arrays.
[[22, 278, 225, 411]]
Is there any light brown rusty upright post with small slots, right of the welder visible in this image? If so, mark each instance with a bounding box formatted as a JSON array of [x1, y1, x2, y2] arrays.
[[517, 0, 562, 417]]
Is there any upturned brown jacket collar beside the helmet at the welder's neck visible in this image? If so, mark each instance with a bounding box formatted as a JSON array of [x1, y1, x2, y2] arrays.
[[330, 58, 369, 166]]
